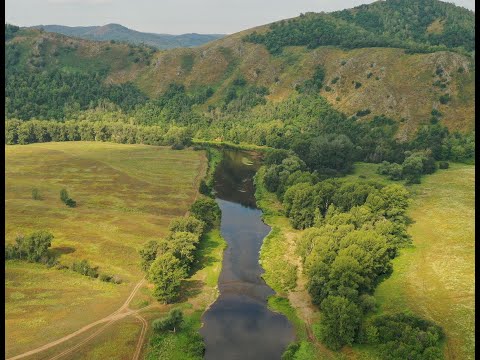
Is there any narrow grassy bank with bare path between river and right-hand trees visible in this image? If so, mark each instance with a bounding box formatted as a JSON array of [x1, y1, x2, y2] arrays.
[[255, 167, 345, 360]]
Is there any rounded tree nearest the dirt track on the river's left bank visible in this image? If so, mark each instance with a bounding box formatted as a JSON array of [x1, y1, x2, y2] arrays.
[[148, 252, 187, 304]]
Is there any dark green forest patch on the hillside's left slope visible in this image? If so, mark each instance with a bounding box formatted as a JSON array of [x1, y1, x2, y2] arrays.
[[5, 57, 146, 120]]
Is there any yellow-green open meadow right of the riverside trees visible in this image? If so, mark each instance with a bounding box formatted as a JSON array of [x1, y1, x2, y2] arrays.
[[375, 164, 475, 360]]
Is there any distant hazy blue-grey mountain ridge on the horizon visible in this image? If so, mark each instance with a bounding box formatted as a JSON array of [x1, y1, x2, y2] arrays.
[[28, 24, 225, 49]]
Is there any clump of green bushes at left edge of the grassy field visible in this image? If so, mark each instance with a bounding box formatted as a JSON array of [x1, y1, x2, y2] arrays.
[[5, 230, 55, 265]]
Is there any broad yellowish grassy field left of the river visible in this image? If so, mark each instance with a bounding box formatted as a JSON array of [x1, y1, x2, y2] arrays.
[[5, 142, 206, 357]]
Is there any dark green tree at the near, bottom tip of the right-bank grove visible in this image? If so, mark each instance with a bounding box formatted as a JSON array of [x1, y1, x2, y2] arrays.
[[319, 296, 362, 350]]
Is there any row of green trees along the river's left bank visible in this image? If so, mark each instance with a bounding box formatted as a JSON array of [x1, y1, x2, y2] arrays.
[[139, 198, 220, 303]]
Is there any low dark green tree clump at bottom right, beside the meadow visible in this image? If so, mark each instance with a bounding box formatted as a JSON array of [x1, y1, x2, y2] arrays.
[[359, 313, 444, 360]]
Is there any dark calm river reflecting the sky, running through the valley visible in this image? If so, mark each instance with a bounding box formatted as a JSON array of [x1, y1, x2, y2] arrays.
[[200, 150, 294, 360]]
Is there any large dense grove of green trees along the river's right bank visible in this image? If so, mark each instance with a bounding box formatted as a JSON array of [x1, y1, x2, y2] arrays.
[[263, 157, 424, 349]]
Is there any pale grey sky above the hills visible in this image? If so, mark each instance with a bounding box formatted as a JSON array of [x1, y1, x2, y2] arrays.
[[5, 0, 475, 34]]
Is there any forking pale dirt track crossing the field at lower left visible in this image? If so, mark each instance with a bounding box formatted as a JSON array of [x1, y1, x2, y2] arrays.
[[7, 279, 147, 360]]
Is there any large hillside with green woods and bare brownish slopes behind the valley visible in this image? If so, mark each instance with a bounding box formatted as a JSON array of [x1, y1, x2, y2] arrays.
[[5, 0, 475, 141]]
